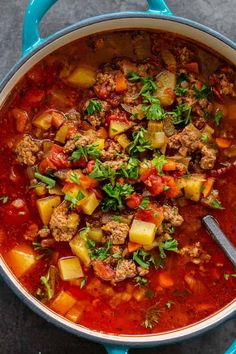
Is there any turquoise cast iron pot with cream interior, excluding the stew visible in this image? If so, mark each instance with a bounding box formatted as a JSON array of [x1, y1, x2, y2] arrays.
[[0, 0, 236, 354]]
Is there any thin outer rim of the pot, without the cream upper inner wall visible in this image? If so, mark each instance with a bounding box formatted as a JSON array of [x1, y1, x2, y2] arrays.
[[0, 11, 236, 346]]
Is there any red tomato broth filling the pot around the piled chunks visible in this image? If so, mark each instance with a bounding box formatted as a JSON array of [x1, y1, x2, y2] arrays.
[[0, 31, 236, 334]]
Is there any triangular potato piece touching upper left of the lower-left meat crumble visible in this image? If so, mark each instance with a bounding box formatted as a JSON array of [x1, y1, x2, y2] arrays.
[[36, 196, 61, 225]]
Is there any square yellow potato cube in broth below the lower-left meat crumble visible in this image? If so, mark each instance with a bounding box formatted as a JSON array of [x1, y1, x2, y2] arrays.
[[58, 257, 84, 280]]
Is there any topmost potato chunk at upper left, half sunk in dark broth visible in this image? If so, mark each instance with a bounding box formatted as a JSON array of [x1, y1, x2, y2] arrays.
[[67, 65, 96, 88]]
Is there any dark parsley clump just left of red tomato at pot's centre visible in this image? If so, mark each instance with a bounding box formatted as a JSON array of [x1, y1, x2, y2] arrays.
[[101, 182, 134, 211]]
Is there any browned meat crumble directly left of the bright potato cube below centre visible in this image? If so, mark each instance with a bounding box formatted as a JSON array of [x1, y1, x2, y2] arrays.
[[102, 221, 129, 245]]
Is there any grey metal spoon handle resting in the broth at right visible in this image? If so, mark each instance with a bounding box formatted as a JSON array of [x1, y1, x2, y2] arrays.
[[202, 215, 236, 267]]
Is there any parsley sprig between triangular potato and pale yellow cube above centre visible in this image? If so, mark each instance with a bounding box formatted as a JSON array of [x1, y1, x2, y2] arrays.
[[128, 127, 152, 157]]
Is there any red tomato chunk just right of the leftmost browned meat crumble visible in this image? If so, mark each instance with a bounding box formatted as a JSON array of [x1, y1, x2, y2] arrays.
[[39, 144, 68, 173]]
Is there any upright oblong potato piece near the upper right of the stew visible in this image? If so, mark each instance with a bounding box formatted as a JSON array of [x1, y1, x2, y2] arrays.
[[155, 70, 176, 106]]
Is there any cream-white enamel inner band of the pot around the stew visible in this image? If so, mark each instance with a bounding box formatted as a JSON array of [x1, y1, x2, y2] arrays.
[[0, 17, 236, 345]]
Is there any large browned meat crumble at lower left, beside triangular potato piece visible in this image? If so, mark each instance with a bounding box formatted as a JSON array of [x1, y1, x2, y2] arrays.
[[49, 203, 79, 241]]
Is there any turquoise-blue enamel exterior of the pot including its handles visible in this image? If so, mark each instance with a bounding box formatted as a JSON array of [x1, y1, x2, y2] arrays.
[[0, 0, 236, 354]]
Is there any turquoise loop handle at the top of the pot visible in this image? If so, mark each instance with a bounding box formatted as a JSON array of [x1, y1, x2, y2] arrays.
[[22, 0, 172, 56]]
